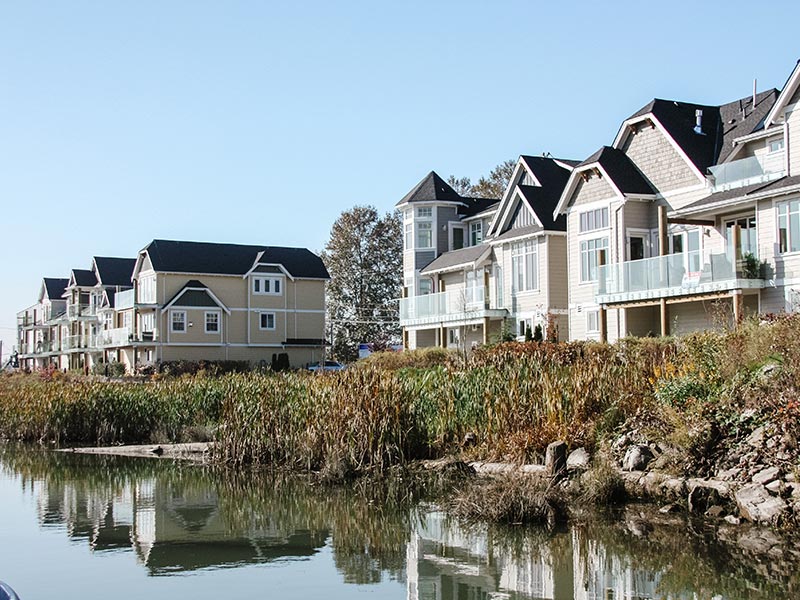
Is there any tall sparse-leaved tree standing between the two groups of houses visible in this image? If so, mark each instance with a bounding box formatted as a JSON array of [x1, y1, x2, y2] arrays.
[[322, 206, 403, 361]]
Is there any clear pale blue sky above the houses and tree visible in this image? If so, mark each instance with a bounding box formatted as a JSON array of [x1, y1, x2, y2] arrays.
[[0, 0, 800, 358]]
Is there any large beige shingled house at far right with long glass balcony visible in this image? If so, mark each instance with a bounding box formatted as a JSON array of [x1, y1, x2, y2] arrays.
[[554, 62, 800, 341]]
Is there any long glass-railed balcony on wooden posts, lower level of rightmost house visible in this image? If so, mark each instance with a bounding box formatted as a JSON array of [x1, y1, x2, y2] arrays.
[[595, 251, 765, 304]]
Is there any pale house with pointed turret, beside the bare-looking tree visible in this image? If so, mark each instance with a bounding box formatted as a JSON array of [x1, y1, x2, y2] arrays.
[[397, 156, 577, 348]]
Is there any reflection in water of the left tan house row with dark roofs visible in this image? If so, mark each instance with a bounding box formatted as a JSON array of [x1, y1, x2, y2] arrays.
[[38, 478, 328, 574]]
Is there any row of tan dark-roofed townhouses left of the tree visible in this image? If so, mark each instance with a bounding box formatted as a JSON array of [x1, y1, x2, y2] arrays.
[[18, 240, 329, 372]]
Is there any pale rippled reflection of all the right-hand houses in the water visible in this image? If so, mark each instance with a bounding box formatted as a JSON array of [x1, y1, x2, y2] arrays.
[[407, 513, 692, 600]]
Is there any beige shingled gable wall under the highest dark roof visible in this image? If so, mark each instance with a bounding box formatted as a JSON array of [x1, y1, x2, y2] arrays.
[[621, 123, 699, 192]]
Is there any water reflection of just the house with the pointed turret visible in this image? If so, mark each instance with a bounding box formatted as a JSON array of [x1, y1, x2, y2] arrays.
[[407, 512, 572, 600]]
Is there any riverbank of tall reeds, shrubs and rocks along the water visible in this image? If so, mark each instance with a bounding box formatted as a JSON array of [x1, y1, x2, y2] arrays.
[[0, 314, 800, 524]]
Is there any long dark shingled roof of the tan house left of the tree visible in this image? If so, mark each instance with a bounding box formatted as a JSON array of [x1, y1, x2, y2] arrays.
[[145, 240, 330, 279]]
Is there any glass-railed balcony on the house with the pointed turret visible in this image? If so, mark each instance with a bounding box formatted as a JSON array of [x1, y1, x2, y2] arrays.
[[400, 287, 508, 327]]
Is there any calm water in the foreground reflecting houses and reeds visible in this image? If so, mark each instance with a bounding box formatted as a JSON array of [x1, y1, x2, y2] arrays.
[[0, 446, 800, 600]]
